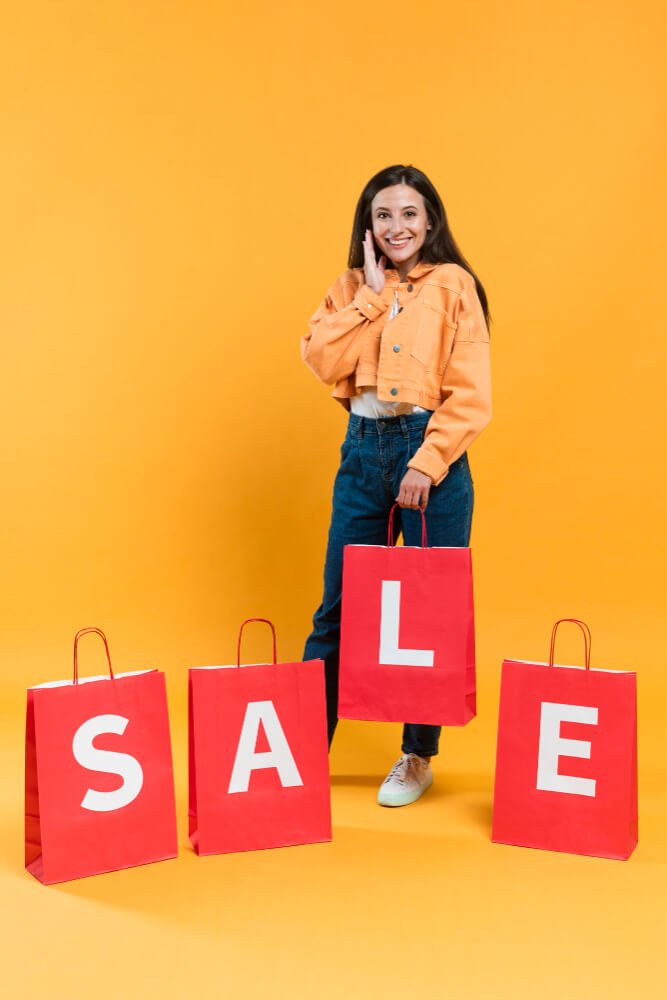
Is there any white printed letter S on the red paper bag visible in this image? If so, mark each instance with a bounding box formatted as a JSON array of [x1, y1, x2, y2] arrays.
[[72, 715, 144, 812]]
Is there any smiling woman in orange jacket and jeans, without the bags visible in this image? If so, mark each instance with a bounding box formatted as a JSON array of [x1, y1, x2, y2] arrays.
[[301, 165, 491, 806]]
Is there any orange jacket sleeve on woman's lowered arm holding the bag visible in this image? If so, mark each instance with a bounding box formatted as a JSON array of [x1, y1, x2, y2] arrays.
[[408, 277, 491, 486]]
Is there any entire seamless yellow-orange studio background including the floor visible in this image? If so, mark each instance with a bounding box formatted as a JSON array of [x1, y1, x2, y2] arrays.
[[0, 0, 667, 998]]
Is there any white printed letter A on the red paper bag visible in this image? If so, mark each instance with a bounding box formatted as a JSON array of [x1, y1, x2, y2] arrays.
[[229, 701, 303, 794]]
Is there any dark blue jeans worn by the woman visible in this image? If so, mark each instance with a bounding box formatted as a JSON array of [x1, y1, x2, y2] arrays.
[[303, 412, 473, 757]]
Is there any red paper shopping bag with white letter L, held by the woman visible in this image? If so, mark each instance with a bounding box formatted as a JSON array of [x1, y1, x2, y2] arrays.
[[338, 504, 476, 726]]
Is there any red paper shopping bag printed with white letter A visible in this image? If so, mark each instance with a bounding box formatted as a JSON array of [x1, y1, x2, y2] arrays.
[[189, 618, 331, 854]]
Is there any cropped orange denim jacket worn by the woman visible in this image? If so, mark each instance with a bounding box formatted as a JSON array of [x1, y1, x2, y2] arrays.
[[301, 261, 491, 486]]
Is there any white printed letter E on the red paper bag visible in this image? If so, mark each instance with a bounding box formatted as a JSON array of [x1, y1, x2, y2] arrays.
[[537, 701, 598, 798]]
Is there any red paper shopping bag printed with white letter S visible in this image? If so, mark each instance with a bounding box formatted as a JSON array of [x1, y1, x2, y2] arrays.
[[25, 628, 178, 885]]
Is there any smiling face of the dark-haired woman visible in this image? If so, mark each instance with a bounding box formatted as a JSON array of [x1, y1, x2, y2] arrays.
[[371, 184, 431, 277]]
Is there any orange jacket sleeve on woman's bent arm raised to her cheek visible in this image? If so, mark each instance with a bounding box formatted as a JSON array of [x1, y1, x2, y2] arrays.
[[301, 278, 387, 385]]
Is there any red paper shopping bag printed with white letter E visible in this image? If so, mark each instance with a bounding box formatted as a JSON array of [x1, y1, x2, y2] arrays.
[[492, 618, 637, 859]]
